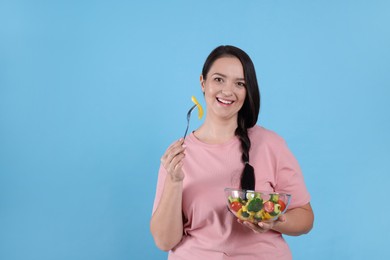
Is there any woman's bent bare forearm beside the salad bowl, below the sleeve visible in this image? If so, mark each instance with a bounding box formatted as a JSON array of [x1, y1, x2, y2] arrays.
[[272, 203, 314, 236]]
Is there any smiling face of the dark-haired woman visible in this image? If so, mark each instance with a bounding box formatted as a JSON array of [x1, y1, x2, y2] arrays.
[[200, 57, 246, 120]]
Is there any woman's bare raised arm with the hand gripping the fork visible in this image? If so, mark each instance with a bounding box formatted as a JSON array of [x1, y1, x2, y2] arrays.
[[150, 139, 185, 251]]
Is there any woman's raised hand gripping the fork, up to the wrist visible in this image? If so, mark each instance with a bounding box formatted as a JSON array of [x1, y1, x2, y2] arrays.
[[161, 138, 185, 182]]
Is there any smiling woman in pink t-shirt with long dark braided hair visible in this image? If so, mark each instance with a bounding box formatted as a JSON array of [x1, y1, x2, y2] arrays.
[[150, 46, 314, 260]]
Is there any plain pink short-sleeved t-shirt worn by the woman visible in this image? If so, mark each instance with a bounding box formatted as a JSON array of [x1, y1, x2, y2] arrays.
[[153, 125, 310, 260]]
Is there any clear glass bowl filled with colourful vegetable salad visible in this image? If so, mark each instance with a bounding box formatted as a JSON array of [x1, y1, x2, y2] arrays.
[[225, 188, 291, 224]]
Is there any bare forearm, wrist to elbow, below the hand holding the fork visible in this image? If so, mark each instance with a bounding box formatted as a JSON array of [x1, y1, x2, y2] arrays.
[[150, 176, 183, 251]]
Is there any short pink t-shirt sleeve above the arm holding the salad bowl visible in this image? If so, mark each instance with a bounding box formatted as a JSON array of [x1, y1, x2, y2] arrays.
[[275, 140, 310, 208]]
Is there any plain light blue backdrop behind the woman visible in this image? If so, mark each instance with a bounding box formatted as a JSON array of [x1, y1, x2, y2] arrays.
[[0, 0, 390, 260]]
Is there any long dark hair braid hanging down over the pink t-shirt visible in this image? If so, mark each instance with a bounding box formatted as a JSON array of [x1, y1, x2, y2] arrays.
[[236, 118, 255, 190]]
